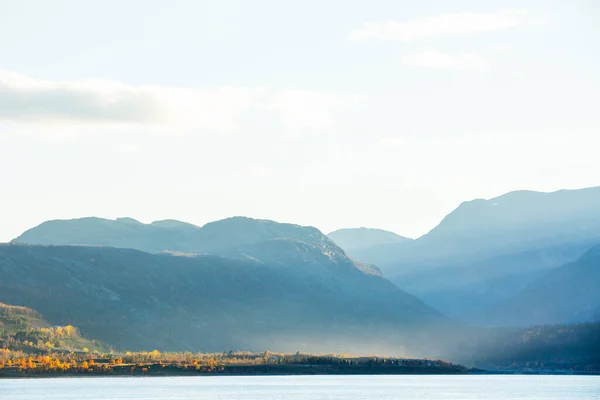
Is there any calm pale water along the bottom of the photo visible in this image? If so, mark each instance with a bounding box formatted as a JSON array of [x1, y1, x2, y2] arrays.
[[0, 375, 600, 400]]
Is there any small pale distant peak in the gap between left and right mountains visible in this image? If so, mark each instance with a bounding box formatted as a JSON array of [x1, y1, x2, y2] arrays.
[[327, 228, 412, 257]]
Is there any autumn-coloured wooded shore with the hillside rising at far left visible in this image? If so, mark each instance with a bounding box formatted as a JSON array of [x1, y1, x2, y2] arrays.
[[0, 303, 468, 378]]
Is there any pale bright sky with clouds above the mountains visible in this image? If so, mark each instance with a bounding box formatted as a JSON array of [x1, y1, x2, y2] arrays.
[[0, 0, 600, 241]]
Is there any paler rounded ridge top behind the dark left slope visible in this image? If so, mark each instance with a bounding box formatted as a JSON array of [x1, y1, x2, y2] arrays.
[[13, 217, 336, 253]]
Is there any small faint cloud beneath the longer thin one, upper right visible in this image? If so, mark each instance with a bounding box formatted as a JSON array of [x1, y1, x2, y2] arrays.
[[402, 49, 489, 71]]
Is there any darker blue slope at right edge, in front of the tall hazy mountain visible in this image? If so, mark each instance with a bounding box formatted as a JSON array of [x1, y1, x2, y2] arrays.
[[482, 246, 600, 326]]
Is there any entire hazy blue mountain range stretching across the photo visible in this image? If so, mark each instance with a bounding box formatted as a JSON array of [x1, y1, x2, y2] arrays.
[[5, 188, 600, 356]]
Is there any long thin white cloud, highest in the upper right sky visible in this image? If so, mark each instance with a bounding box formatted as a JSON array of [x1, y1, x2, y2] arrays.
[[348, 9, 536, 42]]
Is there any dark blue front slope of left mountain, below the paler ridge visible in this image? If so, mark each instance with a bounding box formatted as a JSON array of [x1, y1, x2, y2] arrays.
[[0, 241, 447, 354]]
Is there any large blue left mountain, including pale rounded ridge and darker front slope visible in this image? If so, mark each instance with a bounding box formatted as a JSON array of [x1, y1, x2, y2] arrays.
[[0, 218, 448, 354]]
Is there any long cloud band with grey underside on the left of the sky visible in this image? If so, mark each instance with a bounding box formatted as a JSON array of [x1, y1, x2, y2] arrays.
[[0, 70, 354, 132]]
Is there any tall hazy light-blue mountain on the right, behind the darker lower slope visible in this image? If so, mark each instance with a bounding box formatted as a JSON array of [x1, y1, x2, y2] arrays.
[[344, 187, 600, 319]]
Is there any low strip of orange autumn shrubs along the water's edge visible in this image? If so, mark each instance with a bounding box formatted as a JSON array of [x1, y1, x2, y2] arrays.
[[0, 349, 474, 378]]
